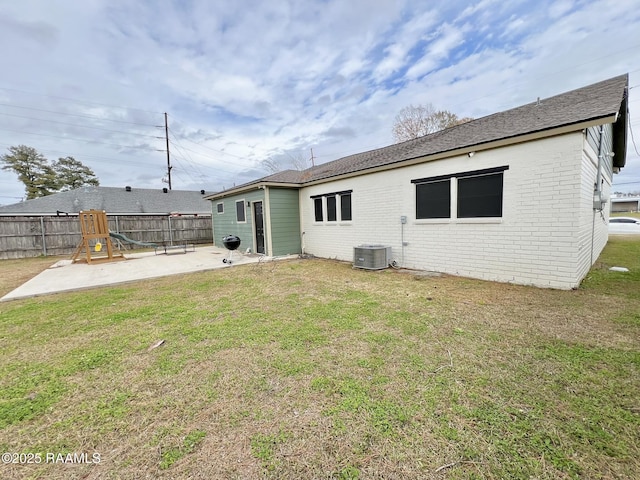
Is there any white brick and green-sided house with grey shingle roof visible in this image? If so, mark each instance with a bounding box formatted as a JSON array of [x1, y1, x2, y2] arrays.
[[205, 75, 628, 289]]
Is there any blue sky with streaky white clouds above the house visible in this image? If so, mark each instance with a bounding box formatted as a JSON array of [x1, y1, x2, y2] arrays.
[[0, 0, 640, 205]]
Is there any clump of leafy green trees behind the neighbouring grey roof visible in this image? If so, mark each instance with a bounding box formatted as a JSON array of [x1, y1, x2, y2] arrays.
[[0, 145, 99, 200]]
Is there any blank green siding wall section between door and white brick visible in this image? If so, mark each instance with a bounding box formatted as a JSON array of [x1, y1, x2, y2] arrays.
[[269, 188, 302, 256]]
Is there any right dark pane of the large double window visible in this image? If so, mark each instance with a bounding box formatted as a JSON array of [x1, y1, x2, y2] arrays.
[[458, 172, 503, 218]]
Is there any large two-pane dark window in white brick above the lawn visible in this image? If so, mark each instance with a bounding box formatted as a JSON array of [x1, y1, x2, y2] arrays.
[[411, 166, 509, 219]]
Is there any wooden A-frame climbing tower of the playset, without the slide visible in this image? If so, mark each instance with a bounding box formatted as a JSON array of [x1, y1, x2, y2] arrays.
[[71, 210, 126, 264]]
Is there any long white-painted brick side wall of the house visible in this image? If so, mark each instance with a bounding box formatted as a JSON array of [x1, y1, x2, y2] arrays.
[[300, 132, 606, 288]]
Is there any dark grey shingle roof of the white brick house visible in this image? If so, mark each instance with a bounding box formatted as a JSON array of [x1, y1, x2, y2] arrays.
[[206, 74, 629, 200]]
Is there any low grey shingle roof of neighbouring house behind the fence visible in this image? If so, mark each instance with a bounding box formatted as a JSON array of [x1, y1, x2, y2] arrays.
[[0, 187, 211, 215]]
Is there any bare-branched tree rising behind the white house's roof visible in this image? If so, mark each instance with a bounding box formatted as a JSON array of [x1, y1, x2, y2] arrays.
[[393, 103, 473, 143]]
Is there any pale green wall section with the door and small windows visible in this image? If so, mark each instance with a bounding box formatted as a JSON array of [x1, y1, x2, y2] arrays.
[[211, 190, 266, 252]]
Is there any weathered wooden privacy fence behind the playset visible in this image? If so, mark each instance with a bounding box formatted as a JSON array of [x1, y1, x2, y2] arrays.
[[0, 214, 213, 260]]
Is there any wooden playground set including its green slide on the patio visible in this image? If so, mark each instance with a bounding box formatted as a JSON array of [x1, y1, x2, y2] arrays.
[[71, 210, 195, 264]]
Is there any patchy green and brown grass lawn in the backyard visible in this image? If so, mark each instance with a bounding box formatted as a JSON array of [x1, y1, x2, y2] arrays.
[[0, 237, 640, 479]]
